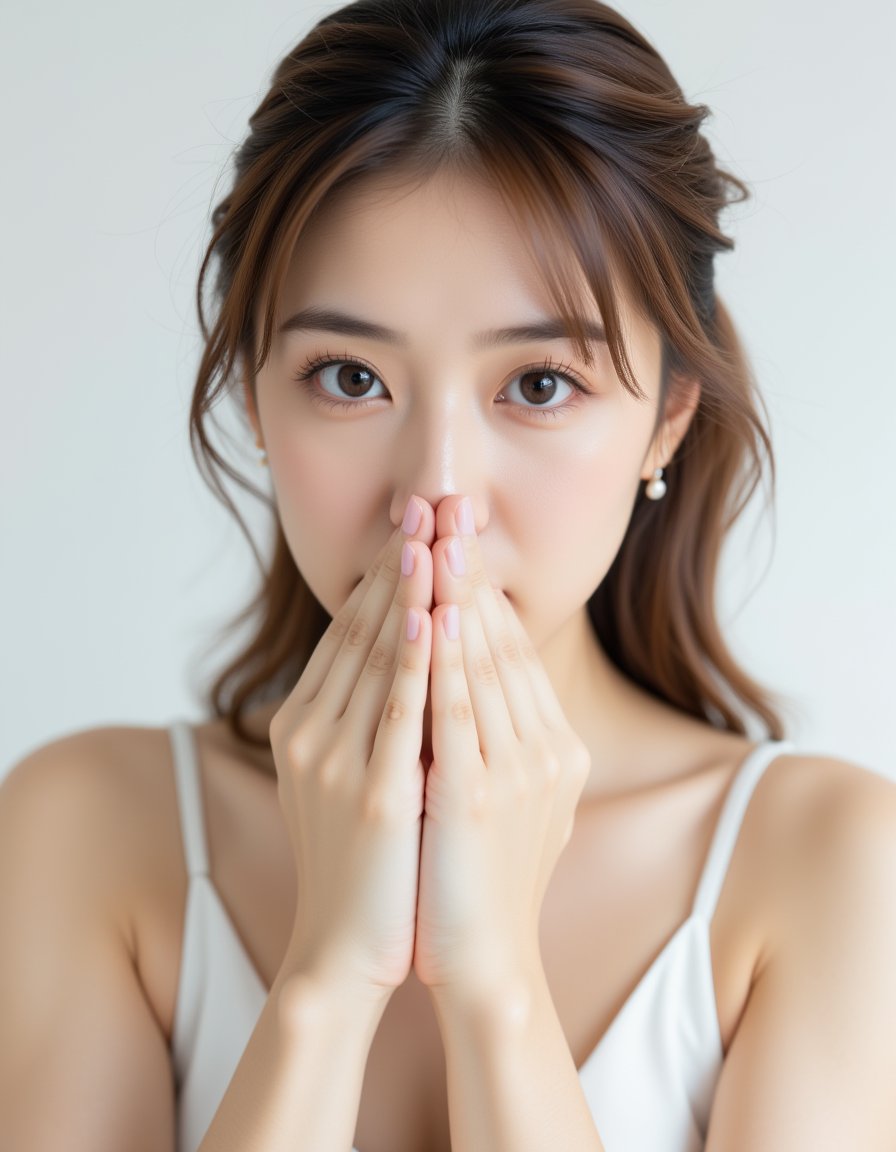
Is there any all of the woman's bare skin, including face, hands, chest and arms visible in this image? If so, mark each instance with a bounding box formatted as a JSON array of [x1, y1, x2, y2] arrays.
[[0, 160, 896, 1152]]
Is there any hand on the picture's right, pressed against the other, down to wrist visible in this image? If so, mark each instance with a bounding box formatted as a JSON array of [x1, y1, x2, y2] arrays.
[[413, 498, 591, 998]]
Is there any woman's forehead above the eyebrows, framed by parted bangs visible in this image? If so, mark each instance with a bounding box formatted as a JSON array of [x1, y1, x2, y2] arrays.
[[261, 169, 659, 391]]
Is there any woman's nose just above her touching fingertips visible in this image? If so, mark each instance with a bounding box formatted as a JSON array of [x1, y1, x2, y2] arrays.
[[390, 393, 489, 533]]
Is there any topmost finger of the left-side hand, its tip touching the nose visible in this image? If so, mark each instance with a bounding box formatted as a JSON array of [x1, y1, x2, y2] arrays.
[[295, 497, 434, 715]]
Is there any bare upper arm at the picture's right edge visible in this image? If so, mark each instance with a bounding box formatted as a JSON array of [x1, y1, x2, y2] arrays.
[[706, 761, 896, 1152]]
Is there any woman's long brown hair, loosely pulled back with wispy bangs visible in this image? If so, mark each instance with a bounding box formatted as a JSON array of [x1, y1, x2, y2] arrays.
[[190, 0, 783, 743]]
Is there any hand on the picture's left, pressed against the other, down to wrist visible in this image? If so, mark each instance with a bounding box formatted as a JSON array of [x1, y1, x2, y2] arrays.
[[271, 498, 435, 992]]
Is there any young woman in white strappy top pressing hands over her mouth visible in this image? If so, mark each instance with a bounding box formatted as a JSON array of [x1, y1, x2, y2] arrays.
[[0, 0, 896, 1152]]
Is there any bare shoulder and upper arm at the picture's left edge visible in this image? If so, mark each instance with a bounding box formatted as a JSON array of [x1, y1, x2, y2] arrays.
[[0, 728, 183, 1152]]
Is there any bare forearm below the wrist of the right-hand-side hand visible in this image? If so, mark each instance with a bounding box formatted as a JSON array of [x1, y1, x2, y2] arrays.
[[433, 973, 603, 1152]]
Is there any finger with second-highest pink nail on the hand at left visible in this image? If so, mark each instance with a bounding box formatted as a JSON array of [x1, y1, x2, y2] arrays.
[[344, 540, 432, 748]]
